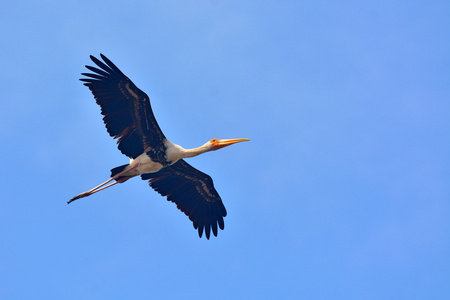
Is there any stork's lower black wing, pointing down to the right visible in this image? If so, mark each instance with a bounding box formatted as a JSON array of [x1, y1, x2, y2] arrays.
[[141, 159, 227, 239]]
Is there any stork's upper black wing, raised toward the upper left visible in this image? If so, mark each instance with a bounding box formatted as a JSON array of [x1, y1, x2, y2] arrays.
[[80, 54, 166, 164]]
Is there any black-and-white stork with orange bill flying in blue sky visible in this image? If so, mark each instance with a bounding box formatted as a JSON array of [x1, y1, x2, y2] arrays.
[[67, 54, 249, 239]]
